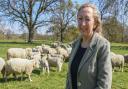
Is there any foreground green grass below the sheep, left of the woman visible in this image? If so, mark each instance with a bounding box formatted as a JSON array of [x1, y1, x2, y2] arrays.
[[0, 64, 67, 89]]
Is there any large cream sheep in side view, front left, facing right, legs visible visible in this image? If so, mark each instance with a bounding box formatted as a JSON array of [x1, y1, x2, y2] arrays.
[[4, 58, 39, 81]]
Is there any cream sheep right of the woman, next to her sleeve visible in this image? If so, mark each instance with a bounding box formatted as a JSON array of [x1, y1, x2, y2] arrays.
[[110, 52, 124, 72]]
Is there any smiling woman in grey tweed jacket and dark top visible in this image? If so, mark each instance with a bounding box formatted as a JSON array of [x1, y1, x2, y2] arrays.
[[66, 3, 112, 89]]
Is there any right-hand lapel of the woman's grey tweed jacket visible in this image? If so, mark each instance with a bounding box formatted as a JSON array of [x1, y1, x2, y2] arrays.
[[78, 33, 98, 73]]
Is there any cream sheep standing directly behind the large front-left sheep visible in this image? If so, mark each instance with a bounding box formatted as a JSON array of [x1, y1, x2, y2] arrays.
[[7, 48, 32, 60]]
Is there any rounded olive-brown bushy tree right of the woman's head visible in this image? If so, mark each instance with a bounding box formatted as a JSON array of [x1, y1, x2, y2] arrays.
[[103, 16, 123, 42]]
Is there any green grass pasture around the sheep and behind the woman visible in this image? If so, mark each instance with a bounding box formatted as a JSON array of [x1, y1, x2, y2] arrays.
[[0, 41, 128, 89]]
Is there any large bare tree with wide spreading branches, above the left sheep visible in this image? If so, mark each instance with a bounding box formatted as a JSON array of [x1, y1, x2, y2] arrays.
[[0, 0, 58, 42]]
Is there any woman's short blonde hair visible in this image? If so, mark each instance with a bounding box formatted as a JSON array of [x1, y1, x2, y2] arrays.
[[77, 3, 102, 34]]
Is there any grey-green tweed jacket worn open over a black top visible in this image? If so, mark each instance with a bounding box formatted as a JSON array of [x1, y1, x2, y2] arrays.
[[66, 32, 112, 89]]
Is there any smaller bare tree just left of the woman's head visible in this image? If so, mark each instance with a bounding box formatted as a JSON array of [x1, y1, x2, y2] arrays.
[[49, 0, 77, 42]]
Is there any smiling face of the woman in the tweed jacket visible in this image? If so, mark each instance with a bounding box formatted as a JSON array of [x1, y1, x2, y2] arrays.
[[77, 7, 94, 36]]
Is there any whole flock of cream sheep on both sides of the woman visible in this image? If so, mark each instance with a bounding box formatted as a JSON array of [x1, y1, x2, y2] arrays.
[[0, 42, 128, 81]]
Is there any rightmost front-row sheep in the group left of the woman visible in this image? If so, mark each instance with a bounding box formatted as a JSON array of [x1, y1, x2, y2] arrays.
[[47, 54, 63, 72]]
